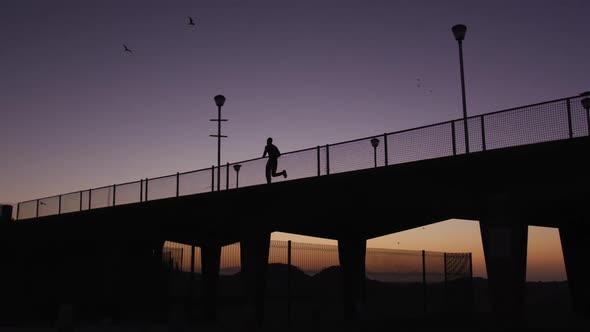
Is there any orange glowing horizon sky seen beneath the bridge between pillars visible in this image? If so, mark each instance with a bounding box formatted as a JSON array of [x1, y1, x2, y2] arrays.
[[165, 219, 567, 281]]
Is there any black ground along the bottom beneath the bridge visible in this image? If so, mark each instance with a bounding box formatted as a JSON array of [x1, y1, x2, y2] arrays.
[[0, 264, 590, 332]]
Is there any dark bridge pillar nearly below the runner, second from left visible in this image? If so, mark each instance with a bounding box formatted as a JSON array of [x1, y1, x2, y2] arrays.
[[240, 232, 270, 325]]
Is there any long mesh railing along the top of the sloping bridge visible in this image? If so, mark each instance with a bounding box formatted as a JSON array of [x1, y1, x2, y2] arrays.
[[16, 96, 590, 220]]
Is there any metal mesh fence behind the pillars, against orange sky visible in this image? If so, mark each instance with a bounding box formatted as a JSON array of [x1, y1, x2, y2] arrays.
[[162, 240, 472, 282]]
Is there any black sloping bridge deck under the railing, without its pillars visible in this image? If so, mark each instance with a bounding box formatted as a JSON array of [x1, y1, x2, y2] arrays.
[[10, 137, 590, 244]]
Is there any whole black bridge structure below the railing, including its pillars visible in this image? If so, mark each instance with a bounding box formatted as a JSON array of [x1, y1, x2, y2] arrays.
[[0, 138, 590, 321]]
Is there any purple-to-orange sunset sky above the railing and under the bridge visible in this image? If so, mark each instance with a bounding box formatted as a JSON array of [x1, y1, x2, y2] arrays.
[[0, 0, 590, 280]]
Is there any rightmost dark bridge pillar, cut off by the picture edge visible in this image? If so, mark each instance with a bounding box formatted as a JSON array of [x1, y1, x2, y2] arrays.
[[559, 219, 590, 317]]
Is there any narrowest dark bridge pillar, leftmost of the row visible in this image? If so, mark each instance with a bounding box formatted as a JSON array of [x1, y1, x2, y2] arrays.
[[201, 244, 221, 321]]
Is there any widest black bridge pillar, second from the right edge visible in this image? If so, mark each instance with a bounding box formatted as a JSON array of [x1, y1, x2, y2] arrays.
[[479, 205, 528, 324]]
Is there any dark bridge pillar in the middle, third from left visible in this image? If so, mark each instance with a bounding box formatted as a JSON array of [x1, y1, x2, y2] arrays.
[[338, 238, 367, 319]]
